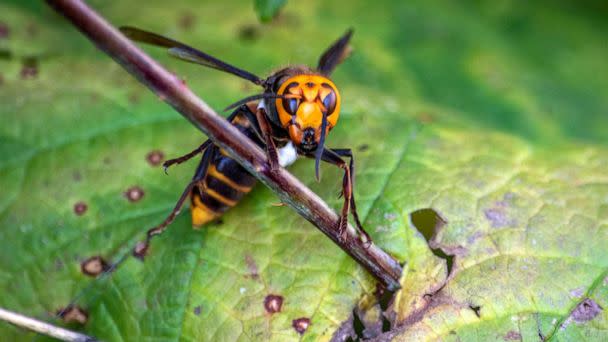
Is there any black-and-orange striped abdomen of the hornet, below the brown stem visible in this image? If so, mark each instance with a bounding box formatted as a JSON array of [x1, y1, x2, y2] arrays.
[[190, 108, 263, 227]]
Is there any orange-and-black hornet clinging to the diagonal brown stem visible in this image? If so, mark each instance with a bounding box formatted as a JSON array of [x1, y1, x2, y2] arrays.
[[116, 27, 370, 258]]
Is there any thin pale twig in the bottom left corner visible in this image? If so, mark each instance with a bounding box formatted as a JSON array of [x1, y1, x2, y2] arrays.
[[0, 308, 96, 342]]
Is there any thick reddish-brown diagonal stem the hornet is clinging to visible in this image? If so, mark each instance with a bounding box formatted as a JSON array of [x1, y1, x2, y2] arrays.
[[47, 0, 402, 290]]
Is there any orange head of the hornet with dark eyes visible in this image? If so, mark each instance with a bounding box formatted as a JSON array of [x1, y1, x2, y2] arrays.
[[275, 74, 340, 153]]
